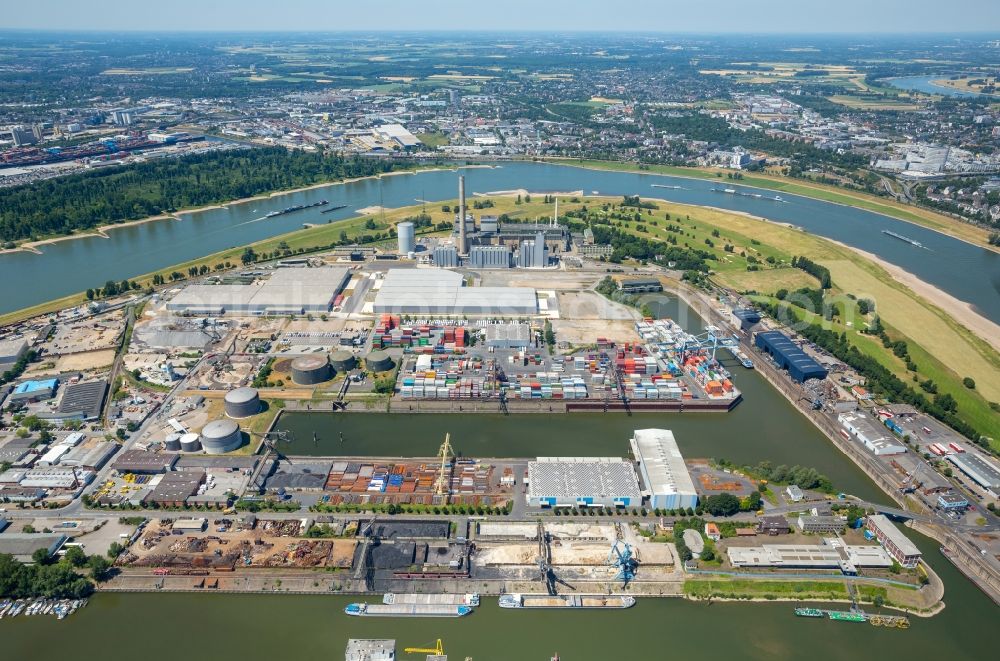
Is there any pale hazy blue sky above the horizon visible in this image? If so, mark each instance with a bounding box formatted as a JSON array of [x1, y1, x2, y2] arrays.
[[2, 0, 1000, 34]]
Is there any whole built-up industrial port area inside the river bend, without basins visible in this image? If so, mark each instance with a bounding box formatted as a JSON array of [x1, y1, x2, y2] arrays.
[[0, 179, 1000, 658]]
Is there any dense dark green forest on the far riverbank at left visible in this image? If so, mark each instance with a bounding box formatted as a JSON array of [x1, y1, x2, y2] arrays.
[[0, 147, 406, 242]]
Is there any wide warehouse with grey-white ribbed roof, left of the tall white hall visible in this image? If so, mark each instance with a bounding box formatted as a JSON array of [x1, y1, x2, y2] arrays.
[[528, 457, 642, 507]]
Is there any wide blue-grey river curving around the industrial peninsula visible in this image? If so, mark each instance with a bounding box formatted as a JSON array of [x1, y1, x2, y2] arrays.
[[0, 163, 1000, 323]]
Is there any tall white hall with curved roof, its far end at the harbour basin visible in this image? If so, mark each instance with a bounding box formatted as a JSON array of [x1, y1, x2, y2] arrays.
[[630, 429, 698, 509]]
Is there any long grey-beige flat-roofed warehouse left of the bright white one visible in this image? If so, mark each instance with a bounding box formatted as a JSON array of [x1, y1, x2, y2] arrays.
[[167, 266, 350, 315]]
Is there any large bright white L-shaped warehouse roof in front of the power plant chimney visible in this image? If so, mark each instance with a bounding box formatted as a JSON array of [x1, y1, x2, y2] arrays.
[[373, 269, 538, 317]]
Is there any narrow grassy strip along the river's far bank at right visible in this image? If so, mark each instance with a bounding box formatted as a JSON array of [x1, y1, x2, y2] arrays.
[[551, 158, 997, 250]]
